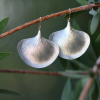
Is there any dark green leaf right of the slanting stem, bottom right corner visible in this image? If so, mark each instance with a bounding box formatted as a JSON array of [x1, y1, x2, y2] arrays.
[[89, 80, 100, 100]]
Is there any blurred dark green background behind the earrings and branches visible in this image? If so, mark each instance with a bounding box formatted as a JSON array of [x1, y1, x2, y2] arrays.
[[0, 0, 92, 100]]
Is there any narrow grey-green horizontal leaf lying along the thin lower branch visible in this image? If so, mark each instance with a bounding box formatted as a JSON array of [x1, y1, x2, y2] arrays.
[[59, 72, 88, 79]]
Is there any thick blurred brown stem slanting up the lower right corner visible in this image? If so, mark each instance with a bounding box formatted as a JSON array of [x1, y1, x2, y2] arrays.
[[78, 57, 100, 100]]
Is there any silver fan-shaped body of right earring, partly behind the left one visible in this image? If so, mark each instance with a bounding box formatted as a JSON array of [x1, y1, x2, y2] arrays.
[[49, 20, 90, 60]]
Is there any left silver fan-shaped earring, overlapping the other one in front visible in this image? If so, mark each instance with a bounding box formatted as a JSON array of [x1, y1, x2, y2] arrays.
[[17, 18, 59, 68]]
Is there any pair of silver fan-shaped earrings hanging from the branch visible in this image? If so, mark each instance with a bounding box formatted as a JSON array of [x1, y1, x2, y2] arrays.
[[17, 18, 90, 68]]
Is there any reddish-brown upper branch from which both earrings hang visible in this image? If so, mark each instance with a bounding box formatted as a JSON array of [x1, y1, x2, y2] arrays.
[[0, 3, 100, 39]]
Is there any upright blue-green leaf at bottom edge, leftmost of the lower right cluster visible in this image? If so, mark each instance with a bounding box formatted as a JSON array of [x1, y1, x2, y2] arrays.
[[61, 79, 71, 100]]
